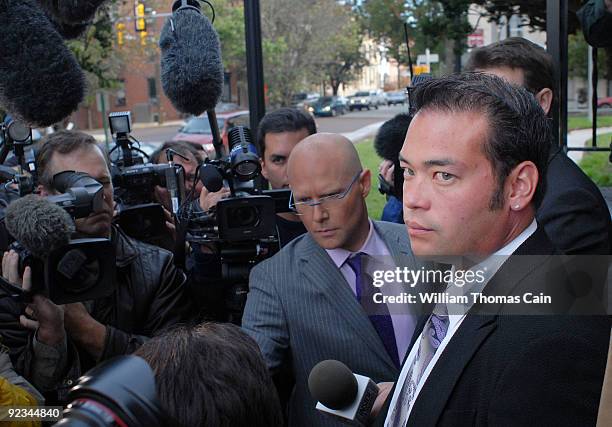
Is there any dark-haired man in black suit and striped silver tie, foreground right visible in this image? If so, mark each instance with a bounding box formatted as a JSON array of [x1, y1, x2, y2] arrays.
[[381, 73, 610, 427]]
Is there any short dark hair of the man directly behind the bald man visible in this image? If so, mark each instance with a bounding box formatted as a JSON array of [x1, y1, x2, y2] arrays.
[[257, 108, 317, 158]]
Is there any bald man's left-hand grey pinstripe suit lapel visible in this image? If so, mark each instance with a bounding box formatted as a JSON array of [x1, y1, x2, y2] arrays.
[[300, 236, 397, 370]]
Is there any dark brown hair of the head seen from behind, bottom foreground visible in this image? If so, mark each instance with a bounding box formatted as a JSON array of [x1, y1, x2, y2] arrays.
[[135, 323, 283, 427]]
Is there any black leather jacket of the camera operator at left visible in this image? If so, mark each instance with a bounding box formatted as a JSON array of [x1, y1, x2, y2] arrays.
[[0, 228, 191, 401]]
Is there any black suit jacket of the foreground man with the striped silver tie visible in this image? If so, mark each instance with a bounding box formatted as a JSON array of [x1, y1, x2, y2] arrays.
[[377, 228, 610, 427]]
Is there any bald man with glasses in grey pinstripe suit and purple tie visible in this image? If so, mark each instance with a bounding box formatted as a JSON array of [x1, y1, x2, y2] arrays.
[[243, 134, 422, 426]]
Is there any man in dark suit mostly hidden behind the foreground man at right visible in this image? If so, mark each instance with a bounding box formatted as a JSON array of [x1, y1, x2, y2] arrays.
[[466, 37, 612, 255]]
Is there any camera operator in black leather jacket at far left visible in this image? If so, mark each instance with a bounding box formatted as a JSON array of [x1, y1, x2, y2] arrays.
[[1, 131, 189, 401]]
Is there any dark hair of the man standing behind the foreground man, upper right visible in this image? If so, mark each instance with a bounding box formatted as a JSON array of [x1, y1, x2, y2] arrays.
[[466, 37, 555, 95]]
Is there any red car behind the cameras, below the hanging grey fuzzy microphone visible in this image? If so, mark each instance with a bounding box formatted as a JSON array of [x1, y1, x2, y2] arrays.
[[172, 110, 250, 156]]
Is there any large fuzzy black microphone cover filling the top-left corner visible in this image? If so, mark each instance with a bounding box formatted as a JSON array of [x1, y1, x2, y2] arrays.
[[0, 0, 85, 127]]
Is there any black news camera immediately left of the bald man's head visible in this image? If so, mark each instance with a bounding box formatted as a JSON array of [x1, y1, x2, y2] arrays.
[[180, 126, 290, 321]]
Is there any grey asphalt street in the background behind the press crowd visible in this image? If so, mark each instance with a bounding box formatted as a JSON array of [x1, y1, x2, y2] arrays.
[[112, 105, 408, 144]]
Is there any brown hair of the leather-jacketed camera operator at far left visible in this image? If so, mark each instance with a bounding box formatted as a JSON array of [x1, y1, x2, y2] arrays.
[[36, 130, 109, 188]]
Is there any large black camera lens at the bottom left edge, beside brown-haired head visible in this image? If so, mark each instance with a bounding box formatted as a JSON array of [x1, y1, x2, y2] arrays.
[[55, 356, 168, 427]]
